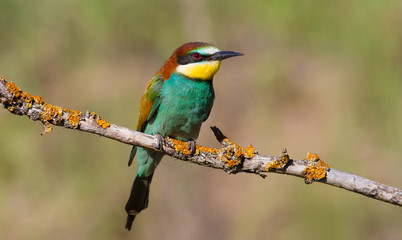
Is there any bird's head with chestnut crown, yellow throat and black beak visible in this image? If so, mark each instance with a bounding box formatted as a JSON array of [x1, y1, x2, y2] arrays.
[[158, 42, 243, 80]]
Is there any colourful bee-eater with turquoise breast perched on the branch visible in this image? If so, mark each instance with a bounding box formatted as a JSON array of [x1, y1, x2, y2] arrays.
[[125, 42, 243, 231]]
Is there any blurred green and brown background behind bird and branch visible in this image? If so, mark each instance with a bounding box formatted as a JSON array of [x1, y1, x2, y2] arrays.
[[0, 0, 402, 239]]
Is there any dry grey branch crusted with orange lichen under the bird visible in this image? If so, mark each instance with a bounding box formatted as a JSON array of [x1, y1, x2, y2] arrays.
[[0, 78, 402, 206]]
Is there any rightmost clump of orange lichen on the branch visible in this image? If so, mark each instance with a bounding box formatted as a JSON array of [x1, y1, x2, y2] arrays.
[[304, 152, 330, 183]]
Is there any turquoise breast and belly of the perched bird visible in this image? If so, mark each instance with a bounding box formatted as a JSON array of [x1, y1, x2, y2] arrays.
[[145, 74, 215, 141]]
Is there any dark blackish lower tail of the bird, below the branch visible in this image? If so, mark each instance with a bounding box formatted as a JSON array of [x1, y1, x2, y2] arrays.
[[125, 174, 153, 231]]
